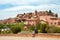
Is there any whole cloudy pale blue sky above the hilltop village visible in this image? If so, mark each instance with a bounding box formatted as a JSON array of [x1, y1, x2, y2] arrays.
[[0, 0, 60, 20]]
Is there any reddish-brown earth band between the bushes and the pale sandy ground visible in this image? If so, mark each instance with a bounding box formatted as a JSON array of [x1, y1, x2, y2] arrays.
[[0, 34, 60, 38]]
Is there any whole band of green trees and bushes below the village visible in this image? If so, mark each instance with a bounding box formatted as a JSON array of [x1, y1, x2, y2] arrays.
[[0, 22, 60, 34]]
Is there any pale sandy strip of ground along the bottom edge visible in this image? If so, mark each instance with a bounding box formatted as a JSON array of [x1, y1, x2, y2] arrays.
[[0, 36, 60, 40]]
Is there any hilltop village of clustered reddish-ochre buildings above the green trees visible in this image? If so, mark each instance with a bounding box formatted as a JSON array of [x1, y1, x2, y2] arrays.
[[0, 10, 60, 26]]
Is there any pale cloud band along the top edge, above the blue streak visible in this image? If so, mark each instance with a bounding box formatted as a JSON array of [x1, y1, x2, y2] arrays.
[[0, 0, 55, 5]]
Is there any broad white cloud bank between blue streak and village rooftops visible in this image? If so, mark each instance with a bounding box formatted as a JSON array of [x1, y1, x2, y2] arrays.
[[0, 4, 60, 19]]
